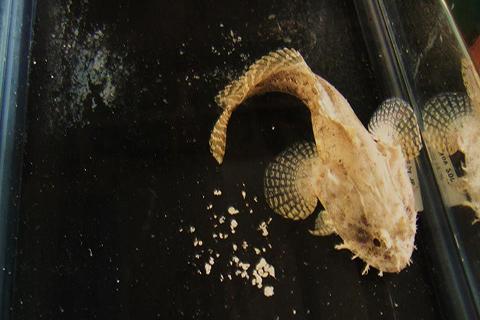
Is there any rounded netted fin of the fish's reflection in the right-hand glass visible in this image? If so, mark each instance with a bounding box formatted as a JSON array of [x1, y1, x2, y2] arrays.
[[422, 92, 473, 154]]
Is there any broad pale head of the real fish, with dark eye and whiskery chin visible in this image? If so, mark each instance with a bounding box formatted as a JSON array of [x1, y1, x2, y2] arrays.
[[322, 131, 416, 273]]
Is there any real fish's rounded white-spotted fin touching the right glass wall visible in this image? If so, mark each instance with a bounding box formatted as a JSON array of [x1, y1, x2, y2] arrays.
[[368, 98, 422, 160]]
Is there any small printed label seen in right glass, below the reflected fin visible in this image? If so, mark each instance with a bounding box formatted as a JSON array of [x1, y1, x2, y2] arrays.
[[430, 149, 467, 207]]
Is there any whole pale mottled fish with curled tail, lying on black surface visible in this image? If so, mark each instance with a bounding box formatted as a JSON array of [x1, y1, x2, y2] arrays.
[[210, 49, 421, 275]]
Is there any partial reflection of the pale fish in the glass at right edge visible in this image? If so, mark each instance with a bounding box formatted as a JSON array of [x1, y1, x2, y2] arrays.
[[422, 59, 480, 223]]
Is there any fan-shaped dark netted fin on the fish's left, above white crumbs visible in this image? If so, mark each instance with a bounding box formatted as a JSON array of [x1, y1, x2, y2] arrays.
[[264, 142, 317, 220]]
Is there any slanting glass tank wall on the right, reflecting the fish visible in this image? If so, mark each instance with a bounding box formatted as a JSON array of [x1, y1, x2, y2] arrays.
[[384, 1, 480, 318]]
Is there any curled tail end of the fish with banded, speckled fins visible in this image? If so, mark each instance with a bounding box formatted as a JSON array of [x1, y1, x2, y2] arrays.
[[210, 48, 317, 163]]
